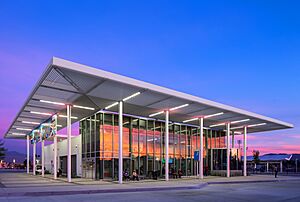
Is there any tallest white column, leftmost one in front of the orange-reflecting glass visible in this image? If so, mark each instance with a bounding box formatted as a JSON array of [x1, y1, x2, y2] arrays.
[[119, 101, 123, 184]]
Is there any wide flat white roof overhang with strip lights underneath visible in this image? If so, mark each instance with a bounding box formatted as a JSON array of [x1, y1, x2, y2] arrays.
[[5, 57, 293, 139]]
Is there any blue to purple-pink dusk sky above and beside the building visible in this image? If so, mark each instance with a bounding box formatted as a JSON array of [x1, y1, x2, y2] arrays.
[[0, 0, 300, 153]]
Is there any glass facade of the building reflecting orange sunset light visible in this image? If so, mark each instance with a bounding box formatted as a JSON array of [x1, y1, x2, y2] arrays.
[[79, 112, 230, 180]]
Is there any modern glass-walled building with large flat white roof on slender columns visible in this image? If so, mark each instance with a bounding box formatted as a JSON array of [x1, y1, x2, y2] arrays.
[[5, 58, 293, 183]]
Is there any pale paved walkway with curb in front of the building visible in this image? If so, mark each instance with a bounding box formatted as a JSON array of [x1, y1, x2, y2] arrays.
[[0, 173, 300, 197]]
